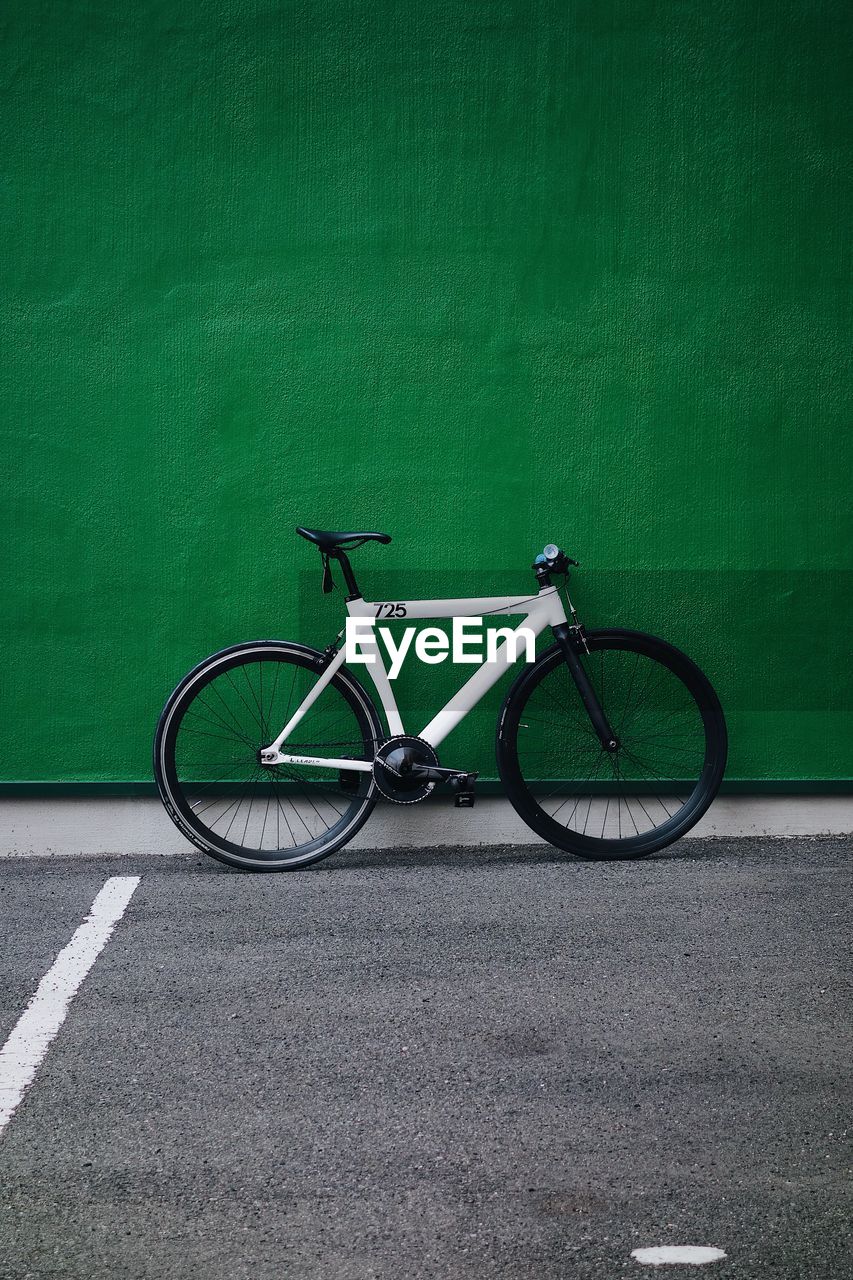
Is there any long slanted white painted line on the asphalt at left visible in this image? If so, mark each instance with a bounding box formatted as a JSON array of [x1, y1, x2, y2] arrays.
[[0, 876, 140, 1133]]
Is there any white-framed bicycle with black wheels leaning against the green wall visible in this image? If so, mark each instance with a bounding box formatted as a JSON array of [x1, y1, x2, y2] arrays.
[[154, 527, 727, 870]]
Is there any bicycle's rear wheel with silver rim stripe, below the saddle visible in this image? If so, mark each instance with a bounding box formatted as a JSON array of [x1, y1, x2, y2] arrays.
[[154, 640, 382, 870]]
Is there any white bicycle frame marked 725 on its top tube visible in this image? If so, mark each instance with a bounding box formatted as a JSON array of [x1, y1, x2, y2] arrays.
[[261, 586, 566, 773]]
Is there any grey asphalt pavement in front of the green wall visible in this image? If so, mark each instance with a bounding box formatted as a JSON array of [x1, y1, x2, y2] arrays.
[[0, 838, 853, 1280]]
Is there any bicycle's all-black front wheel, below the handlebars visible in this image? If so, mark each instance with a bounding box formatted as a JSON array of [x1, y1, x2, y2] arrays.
[[497, 630, 727, 859]]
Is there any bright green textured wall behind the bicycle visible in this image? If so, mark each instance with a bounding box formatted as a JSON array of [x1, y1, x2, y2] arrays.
[[0, 0, 853, 782]]
